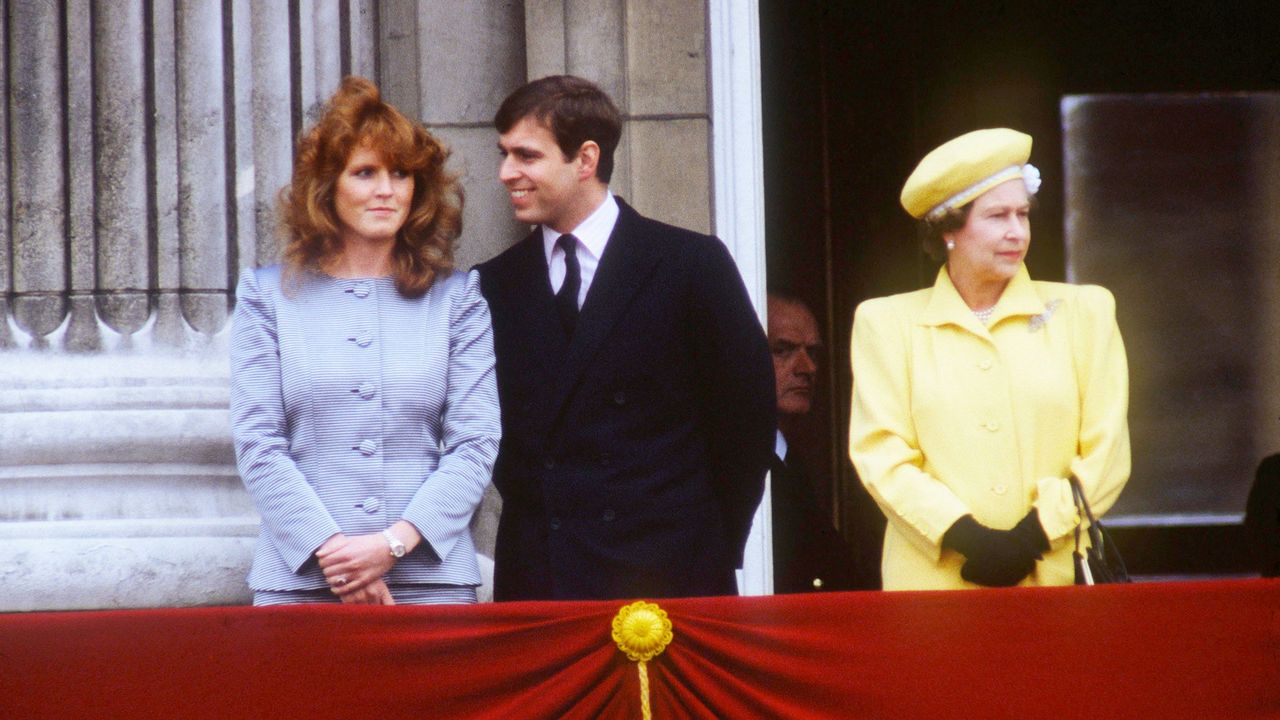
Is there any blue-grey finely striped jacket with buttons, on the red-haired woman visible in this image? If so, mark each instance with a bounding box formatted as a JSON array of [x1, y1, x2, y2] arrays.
[[230, 265, 500, 589]]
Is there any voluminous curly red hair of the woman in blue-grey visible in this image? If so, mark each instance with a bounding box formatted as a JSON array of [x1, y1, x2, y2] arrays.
[[279, 77, 462, 297]]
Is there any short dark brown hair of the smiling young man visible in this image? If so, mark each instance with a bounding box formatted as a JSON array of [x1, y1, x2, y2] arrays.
[[493, 76, 622, 183]]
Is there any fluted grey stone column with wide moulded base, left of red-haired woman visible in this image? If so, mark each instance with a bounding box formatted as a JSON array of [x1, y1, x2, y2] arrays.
[[0, 0, 379, 611]]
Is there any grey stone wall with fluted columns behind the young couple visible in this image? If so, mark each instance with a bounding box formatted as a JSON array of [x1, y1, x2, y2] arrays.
[[0, 0, 747, 610]]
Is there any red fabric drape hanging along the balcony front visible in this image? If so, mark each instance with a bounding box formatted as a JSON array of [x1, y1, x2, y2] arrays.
[[0, 580, 1280, 720]]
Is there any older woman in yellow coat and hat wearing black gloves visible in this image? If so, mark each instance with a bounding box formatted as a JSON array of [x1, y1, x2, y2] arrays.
[[849, 128, 1129, 589]]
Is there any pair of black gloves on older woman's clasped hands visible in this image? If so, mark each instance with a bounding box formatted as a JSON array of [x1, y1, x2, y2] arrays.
[[942, 509, 1048, 587]]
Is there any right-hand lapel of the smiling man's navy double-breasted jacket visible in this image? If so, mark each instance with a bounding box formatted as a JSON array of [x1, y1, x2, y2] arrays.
[[544, 200, 662, 427]]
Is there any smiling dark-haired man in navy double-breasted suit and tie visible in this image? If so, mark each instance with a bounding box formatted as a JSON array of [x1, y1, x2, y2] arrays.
[[480, 76, 776, 600]]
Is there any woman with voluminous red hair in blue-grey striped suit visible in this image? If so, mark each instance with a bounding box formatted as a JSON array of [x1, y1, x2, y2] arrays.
[[230, 77, 500, 605]]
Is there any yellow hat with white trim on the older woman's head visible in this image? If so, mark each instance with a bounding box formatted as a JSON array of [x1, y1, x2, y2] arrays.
[[901, 128, 1039, 219]]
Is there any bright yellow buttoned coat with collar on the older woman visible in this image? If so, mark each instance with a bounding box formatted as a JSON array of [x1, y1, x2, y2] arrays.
[[849, 266, 1129, 589]]
